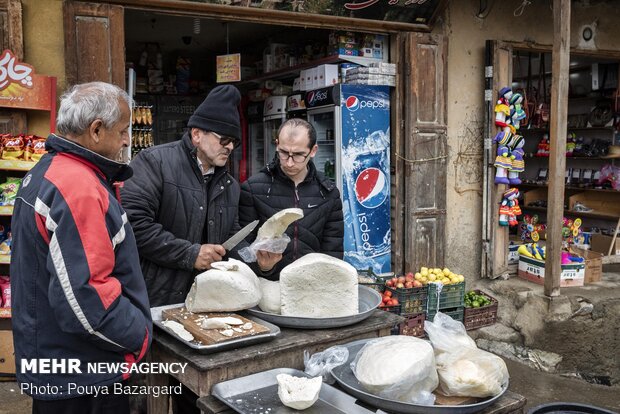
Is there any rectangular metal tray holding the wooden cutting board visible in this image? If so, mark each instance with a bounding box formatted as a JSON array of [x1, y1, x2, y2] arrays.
[[151, 303, 280, 354]]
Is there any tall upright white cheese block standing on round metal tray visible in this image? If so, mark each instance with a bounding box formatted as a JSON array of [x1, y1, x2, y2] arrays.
[[280, 253, 359, 318]]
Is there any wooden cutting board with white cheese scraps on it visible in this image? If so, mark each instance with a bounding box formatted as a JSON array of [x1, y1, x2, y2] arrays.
[[162, 306, 269, 345]]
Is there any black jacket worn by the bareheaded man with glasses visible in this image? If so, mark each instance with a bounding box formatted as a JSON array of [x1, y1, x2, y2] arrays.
[[239, 158, 344, 280]]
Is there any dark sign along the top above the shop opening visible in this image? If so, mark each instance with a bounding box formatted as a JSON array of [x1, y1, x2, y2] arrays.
[[188, 0, 440, 25]]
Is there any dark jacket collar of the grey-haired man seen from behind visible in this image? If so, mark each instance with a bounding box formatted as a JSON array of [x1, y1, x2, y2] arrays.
[[45, 134, 133, 182]]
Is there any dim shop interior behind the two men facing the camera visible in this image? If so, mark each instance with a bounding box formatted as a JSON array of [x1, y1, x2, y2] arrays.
[[125, 9, 394, 181]]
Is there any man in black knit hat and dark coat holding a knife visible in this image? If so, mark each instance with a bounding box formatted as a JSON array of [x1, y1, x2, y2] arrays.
[[122, 85, 281, 307]]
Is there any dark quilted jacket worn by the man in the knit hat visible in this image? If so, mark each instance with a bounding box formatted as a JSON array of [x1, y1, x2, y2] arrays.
[[121, 133, 242, 306]]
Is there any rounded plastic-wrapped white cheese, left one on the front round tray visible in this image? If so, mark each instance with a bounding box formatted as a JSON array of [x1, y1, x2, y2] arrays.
[[351, 336, 439, 405]]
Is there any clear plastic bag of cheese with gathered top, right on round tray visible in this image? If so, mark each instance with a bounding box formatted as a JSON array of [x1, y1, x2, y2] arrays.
[[424, 312, 508, 398]]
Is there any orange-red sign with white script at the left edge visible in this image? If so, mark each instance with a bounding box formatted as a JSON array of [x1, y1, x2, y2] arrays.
[[0, 49, 56, 111]]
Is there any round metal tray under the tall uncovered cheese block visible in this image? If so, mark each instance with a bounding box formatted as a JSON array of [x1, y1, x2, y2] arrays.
[[246, 285, 381, 329]]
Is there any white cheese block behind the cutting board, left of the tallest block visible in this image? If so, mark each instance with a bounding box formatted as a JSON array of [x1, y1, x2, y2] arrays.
[[185, 259, 261, 312]]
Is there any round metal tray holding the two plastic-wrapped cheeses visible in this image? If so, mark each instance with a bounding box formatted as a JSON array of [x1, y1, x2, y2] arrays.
[[332, 338, 508, 414]]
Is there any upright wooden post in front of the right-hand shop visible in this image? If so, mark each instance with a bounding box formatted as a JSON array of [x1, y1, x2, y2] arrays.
[[545, 0, 570, 296]]
